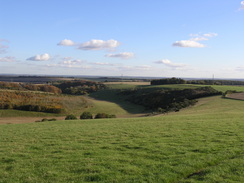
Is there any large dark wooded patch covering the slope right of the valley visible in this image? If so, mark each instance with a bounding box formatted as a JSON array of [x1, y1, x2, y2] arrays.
[[120, 87, 222, 113]]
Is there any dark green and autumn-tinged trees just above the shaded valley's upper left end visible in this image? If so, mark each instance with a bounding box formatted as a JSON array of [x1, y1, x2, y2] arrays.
[[55, 80, 106, 95]]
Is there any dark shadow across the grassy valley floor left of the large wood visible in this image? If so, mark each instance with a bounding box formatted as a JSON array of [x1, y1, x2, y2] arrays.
[[89, 89, 150, 114]]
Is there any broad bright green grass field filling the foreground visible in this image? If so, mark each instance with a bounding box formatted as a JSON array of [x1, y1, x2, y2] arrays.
[[0, 96, 244, 183]]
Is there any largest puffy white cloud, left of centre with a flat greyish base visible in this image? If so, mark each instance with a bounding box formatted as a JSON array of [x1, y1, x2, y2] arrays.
[[78, 39, 120, 50]]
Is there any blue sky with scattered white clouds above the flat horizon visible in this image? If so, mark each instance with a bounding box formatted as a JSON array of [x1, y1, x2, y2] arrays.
[[0, 0, 244, 79]]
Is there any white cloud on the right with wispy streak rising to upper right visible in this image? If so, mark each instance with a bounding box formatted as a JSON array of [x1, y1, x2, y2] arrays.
[[172, 33, 218, 48]]
